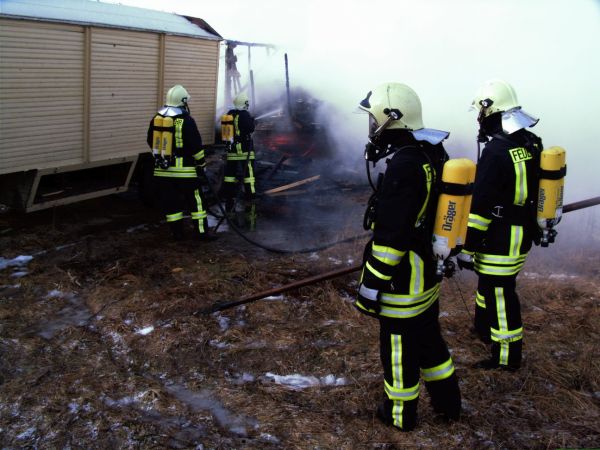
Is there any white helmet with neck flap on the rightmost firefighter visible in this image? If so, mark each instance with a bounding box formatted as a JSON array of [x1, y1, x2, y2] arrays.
[[471, 79, 539, 134]]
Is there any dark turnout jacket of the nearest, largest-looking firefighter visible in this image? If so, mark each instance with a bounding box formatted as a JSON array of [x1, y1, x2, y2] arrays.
[[355, 135, 448, 319]]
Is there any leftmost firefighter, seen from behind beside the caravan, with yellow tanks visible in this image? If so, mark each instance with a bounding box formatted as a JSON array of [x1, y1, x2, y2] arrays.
[[147, 84, 215, 240]]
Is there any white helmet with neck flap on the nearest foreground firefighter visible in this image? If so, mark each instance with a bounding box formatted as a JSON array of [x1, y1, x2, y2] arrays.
[[359, 83, 449, 144]]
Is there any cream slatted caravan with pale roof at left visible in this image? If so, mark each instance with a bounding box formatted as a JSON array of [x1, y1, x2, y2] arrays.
[[0, 0, 222, 211]]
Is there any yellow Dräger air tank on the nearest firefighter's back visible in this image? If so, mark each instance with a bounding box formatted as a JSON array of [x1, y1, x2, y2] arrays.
[[433, 158, 476, 275]]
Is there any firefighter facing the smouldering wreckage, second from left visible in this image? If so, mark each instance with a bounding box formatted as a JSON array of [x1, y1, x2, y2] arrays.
[[221, 92, 256, 220]]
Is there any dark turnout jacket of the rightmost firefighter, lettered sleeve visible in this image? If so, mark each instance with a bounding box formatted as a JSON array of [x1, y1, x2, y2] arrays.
[[464, 129, 542, 276]]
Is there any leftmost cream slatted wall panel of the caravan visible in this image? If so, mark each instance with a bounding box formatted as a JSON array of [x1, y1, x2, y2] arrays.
[[0, 19, 84, 174]]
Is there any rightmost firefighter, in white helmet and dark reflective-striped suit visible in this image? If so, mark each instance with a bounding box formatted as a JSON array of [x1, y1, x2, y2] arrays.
[[457, 79, 542, 371]]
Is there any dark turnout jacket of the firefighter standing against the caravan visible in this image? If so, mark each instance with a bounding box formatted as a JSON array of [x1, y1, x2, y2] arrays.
[[147, 107, 206, 178]]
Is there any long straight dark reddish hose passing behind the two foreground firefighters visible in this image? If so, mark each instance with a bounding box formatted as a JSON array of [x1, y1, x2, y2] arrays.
[[200, 196, 600, 316]]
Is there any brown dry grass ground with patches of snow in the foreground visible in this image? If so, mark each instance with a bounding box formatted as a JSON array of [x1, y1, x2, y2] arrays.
[[0, 194, 600, 449]]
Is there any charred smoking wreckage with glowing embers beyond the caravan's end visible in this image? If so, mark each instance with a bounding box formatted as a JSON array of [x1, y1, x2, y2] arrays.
[[212, 40, 334, 201]]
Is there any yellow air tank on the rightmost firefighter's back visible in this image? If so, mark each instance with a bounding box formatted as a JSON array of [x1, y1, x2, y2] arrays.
[[537, 147, 567, 247]]
